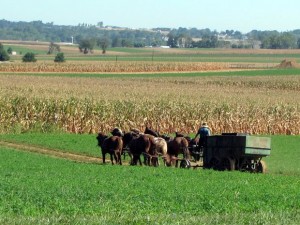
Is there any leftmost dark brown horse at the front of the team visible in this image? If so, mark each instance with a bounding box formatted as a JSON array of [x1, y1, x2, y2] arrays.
[[96, 133, 123, 165]]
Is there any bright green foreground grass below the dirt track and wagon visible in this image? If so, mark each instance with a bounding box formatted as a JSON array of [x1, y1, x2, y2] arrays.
[[0, 143, 300, 224]]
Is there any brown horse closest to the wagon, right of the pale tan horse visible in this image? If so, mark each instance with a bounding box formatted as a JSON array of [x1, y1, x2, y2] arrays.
[[166, 137, 190, 167]]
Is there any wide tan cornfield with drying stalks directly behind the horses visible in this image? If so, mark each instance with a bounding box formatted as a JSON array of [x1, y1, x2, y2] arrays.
[[0, 75, 300, 134]]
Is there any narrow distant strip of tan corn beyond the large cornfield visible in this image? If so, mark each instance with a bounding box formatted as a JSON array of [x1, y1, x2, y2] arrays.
[[0, 61, 229, 73]]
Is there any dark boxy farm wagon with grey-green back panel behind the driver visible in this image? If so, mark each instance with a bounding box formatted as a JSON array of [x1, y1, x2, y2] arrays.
[[203, 133, 271, 173]]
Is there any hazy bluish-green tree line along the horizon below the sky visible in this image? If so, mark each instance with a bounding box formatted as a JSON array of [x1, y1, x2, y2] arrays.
[[0, 20, 300, 49]]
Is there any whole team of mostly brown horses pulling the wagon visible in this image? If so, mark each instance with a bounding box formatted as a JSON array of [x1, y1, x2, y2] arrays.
[[97, 127, 198, 167]]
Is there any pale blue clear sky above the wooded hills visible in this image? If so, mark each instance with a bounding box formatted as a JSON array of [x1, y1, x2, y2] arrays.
[[0, 0, 300, 33]]
